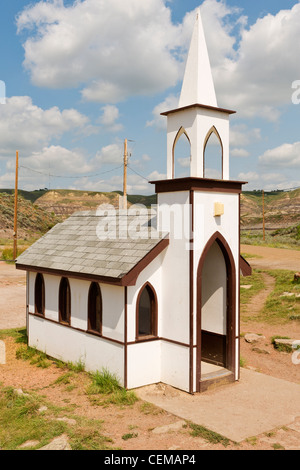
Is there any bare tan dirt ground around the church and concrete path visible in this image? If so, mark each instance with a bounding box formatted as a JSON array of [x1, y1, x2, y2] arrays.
[[0, 250, 300, 451]]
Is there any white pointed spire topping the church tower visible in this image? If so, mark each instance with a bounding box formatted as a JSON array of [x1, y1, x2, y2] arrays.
[[179, 8, 218, 108]]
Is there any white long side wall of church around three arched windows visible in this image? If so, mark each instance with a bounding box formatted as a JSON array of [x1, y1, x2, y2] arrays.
[[28, 273, 124, 383]]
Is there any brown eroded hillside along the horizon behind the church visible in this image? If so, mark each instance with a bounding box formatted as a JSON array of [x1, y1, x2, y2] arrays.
[[0, 188, 300, 242]]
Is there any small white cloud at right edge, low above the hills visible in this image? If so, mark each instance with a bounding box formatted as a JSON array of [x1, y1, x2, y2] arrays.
[[259, 142, 300, 169]]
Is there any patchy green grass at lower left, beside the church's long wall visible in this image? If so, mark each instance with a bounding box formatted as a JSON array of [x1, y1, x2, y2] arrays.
[[0, 329, 137, 450]]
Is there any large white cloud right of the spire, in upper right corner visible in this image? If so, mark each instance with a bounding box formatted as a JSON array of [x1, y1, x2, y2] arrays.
[[209, 0, 300, 121]]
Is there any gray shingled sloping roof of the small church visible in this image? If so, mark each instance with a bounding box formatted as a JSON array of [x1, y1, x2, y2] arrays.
[[16, 207, 166, 278]]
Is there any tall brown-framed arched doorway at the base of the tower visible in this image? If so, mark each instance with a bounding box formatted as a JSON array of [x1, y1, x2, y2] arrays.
[[196, 232, 236, 391]]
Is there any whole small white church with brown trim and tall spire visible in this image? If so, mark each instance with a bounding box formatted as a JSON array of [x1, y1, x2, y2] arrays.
[[16, 13, 244, 393]]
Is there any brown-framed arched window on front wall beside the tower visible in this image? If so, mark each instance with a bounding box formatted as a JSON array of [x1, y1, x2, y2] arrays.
[[136, 284, 157, 339]]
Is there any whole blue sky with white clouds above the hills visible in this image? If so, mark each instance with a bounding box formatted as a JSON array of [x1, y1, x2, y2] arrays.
[[0, 0, 300, 194]]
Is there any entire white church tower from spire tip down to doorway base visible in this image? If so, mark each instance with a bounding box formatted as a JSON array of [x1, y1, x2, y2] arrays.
[[151, 9, 244, 393]]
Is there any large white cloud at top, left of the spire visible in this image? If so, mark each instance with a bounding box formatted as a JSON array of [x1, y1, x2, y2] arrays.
[[17, 0, 181, 103]]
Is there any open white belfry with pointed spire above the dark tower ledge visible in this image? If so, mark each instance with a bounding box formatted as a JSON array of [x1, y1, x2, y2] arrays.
[[162, 10, 234, 180]]
